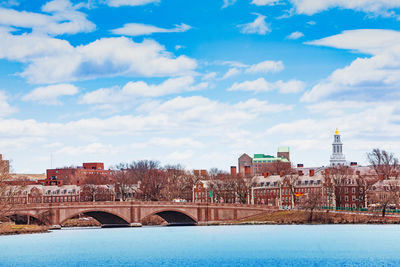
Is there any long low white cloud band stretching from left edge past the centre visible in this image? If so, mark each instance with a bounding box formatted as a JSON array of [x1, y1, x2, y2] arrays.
[[0, 96, 290, 142]]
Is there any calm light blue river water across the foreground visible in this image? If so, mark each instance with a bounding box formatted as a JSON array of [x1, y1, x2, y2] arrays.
[[0, 225, 400, 267]]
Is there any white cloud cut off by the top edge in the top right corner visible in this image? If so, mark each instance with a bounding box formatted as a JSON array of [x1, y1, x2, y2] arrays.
[[290, 0, 400, 16]]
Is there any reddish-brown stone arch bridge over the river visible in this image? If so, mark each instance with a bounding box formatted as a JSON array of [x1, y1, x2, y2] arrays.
[[13, 201, 278, 227]]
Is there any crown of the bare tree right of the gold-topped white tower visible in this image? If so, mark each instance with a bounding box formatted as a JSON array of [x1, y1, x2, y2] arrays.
[[367, 148, 399, 180]]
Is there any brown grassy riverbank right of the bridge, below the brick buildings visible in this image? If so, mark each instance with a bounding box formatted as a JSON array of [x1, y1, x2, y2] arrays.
[[228, 210, 400, 224]]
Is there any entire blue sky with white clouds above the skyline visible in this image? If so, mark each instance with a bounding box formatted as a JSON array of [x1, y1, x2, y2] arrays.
[[0, 0, 400, 173]]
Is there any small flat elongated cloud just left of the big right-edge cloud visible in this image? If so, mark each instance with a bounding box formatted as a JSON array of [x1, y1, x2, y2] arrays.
[[228, 78, 305, 94]]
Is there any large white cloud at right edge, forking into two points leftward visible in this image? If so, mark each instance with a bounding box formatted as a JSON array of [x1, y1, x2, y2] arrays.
[[301, 30, 400, 102]]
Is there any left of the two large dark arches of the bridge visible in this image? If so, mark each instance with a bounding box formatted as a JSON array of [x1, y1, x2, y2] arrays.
[[60, 209, 130, 227]]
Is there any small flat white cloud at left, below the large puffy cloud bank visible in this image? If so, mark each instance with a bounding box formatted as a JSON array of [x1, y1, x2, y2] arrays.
[[22, 84, 79, 105]]
